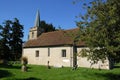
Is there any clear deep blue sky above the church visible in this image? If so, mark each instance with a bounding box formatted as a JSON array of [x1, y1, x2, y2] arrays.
[[0, 0, 89, 41]]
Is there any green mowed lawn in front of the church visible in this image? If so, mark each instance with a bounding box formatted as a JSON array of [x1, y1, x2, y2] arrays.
[[0, 65, 120, 80]]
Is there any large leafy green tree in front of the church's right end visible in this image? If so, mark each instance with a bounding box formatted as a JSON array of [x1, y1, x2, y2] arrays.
[[77, 0, 120, 63]]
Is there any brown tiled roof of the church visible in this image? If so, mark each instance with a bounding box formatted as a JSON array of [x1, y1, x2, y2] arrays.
[[24, 28, 84, 47]]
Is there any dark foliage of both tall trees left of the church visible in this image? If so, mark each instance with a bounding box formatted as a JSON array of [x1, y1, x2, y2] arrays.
[[0, 18, 23, 60]]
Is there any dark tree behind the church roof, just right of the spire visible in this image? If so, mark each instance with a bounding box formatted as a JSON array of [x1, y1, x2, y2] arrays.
[[40, 21, 56, 32]]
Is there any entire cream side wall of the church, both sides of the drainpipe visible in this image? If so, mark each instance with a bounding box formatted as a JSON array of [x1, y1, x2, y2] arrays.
[[23, 47, 109, 69]]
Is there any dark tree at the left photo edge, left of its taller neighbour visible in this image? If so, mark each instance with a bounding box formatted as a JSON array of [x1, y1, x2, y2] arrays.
[[0, 20, 11, 60]]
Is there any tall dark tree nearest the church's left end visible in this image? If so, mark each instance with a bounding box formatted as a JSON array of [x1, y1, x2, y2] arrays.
[[10, 18, 23, 60]]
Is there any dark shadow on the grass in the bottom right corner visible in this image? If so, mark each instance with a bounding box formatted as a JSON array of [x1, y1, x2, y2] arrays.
[[95, 73, 120, 80]]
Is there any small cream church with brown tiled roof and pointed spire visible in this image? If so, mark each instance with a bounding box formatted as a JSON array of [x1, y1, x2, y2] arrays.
[[22, 11, 111, 69]]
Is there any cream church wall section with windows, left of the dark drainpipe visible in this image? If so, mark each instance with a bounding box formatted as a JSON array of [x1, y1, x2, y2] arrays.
[[23, 47, 72, 67]]
